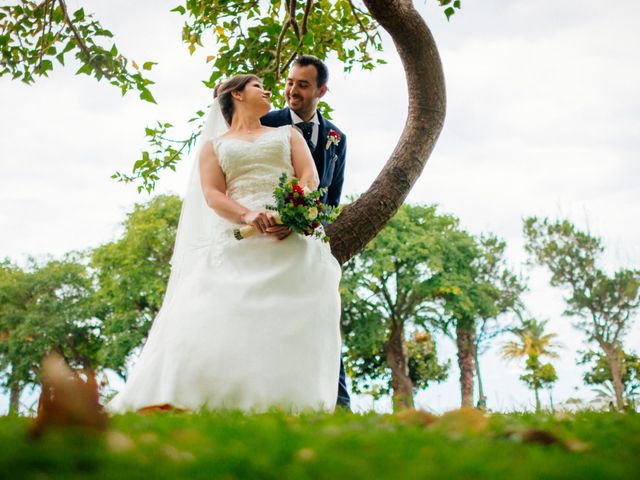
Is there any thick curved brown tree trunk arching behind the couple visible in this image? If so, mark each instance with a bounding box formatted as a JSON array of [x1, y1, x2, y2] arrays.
[[327, 0, 446, 263]]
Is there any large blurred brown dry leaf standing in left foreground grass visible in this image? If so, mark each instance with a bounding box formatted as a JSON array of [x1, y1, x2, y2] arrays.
[[29, 354, 107, 437]]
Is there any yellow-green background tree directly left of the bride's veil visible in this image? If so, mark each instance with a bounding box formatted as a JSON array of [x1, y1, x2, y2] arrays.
[[91, 195, 181, 377]]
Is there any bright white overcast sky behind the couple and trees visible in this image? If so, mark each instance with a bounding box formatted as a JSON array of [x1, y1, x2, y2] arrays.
[[0, 0, 640, 412]]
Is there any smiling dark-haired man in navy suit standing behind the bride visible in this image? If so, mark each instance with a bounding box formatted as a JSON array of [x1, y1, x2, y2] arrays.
[[261, 55, 351, 409]]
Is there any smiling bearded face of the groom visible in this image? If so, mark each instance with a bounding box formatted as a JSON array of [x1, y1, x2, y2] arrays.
[[284, 65, 327, 120]]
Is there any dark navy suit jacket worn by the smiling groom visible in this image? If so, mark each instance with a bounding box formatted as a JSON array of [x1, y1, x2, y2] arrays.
[[260, 107, 347, 206]]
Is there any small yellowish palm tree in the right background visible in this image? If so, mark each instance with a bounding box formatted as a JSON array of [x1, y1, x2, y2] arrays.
[[502, 318, 561, 411]]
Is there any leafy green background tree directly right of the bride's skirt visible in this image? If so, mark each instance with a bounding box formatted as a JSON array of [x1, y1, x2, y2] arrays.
[[340, 205, 452, 410]]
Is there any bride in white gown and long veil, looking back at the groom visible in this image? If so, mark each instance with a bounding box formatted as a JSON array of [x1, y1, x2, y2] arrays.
[[107, 75, 341, 412]]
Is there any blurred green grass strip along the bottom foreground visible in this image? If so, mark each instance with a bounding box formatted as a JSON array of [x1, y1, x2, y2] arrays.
[[0, 412, 640, 480]]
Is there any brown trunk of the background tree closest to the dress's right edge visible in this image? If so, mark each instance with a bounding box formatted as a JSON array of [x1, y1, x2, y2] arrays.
[[386, 323, 413, 412]]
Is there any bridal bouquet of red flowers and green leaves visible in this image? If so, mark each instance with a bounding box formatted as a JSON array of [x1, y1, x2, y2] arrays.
[[233, 172, 338, 242]]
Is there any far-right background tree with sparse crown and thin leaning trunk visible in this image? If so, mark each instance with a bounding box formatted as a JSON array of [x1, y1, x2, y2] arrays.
[[524, 217, 640, 409]]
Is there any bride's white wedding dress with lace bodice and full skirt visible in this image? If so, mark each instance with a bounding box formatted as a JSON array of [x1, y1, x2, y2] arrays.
[[107, 126, 341, 412]]
